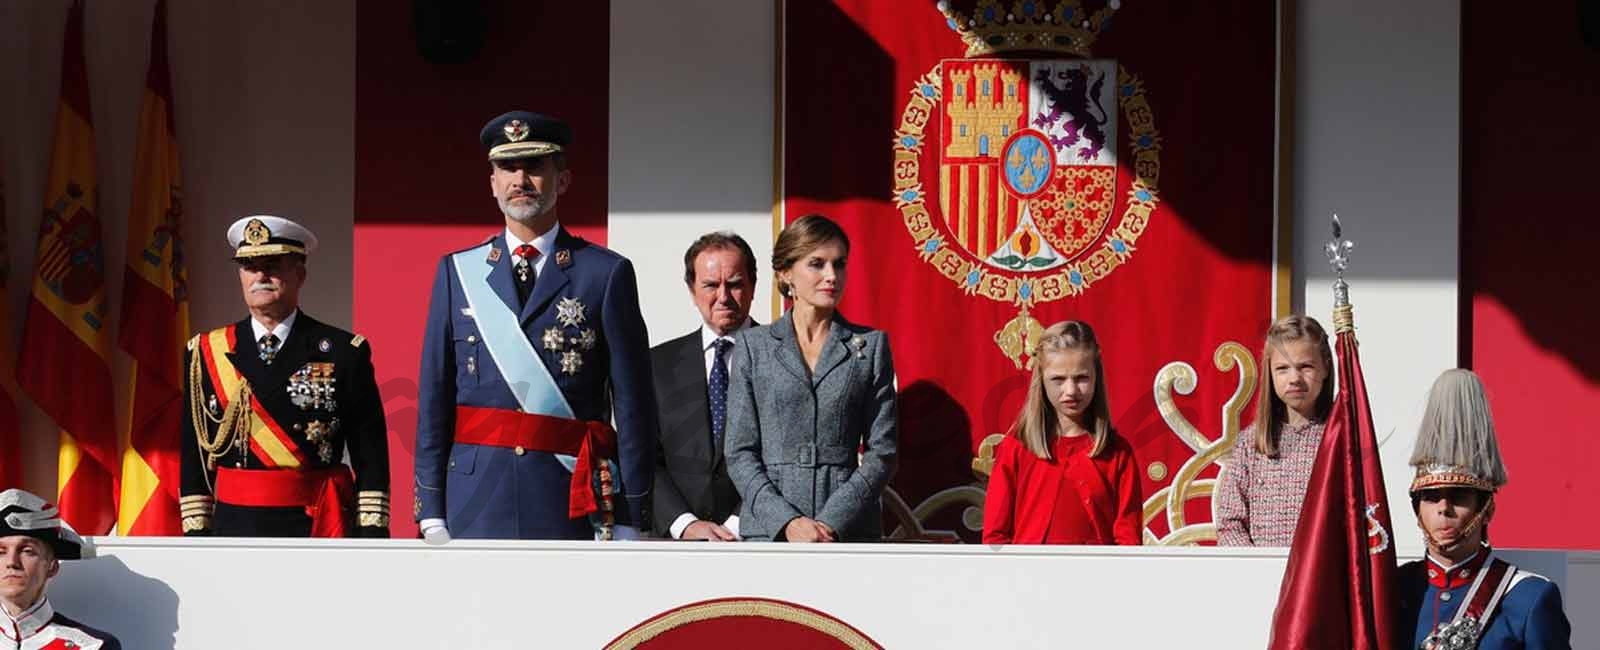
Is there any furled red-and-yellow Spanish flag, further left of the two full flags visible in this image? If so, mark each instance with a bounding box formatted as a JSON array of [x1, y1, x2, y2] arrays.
[[16, 0, 117, 535]]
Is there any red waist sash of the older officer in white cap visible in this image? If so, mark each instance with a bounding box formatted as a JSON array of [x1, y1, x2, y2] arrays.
[[216, 464, 355, 538]]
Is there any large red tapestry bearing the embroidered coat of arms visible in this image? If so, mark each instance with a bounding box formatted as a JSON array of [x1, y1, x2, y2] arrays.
[[774, 0, 1288, 543]]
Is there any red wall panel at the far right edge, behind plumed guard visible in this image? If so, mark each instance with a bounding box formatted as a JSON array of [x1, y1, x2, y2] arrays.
[[1461, 2, 1600, 549]]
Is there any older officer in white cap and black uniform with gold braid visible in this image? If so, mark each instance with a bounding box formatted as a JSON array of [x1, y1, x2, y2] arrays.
[[179, 215, 389, 536]]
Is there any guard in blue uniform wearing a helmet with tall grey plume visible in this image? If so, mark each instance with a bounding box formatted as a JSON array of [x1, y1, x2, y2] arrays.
[[1397, 370, 1571, 650]]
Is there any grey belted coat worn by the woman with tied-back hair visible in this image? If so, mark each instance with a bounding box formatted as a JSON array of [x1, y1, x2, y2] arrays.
[[723, 314, 898, 541]]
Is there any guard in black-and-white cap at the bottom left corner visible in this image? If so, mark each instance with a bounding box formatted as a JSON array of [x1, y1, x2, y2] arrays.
[[0, 488, 122, 650]]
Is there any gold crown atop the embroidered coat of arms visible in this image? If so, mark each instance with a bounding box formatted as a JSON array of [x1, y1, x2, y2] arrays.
[[938, 0, 1122, 58]]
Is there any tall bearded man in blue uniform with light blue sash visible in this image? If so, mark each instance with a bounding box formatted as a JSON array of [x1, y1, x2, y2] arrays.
[[413, 110, 656, 540]]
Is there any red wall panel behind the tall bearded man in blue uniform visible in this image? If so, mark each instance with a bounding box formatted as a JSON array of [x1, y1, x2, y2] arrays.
[[352, 0, 611, 536]]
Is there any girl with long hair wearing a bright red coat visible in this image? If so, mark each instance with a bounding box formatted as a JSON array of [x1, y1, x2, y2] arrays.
[[984, 320, 1144, 546]]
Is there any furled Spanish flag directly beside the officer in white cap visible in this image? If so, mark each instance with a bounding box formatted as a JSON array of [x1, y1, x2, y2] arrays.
[[117, 0, 189, 535]]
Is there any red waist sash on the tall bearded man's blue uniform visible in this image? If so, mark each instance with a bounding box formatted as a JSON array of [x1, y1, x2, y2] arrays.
[[456, 407, 616, 519]]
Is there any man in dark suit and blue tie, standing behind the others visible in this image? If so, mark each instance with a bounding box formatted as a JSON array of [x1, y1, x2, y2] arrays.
[[650, 232, 755, 541]]
